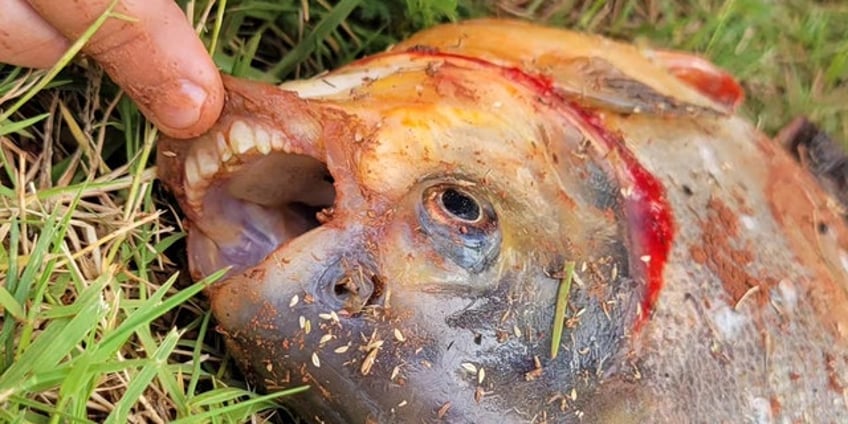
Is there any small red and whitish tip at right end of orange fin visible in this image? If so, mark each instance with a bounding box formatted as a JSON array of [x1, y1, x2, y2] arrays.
[[652, 50, 745, 112]]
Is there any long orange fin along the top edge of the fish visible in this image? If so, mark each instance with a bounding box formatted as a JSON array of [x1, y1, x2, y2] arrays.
[[393, 19, 744, 116]]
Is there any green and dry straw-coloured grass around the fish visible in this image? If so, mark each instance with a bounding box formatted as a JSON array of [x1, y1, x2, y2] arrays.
[[0, 0, 848, 423]]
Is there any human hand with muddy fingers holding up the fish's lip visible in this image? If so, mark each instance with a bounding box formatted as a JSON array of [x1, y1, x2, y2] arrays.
[[0, 0, 224, 138]]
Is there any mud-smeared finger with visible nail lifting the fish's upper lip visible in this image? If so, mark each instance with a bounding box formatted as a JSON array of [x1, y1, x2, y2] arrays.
[[28, 0, 224, 138]]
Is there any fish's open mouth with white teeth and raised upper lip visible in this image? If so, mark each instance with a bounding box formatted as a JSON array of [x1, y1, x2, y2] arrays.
[[159, 78, 336, 278]]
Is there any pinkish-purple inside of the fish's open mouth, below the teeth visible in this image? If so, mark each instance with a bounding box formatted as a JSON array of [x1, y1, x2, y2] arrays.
[[188, 152, 335, 276]]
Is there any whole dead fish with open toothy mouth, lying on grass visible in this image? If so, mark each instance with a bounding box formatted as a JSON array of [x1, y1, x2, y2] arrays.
[[157, 19, 848, 423]]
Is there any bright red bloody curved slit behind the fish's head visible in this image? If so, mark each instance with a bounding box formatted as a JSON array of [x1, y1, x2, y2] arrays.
[[376, 49, 674, 331]]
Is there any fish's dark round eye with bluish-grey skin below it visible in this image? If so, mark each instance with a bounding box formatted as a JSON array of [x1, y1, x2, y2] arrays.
[[418, 183, 501, 273]]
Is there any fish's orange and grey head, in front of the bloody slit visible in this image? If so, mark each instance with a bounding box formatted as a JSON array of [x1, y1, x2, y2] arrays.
[[160, 52, 643, 422]]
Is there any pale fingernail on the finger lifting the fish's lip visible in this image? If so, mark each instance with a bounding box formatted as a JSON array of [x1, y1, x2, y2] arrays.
[[151, 80, 207, 130]]
